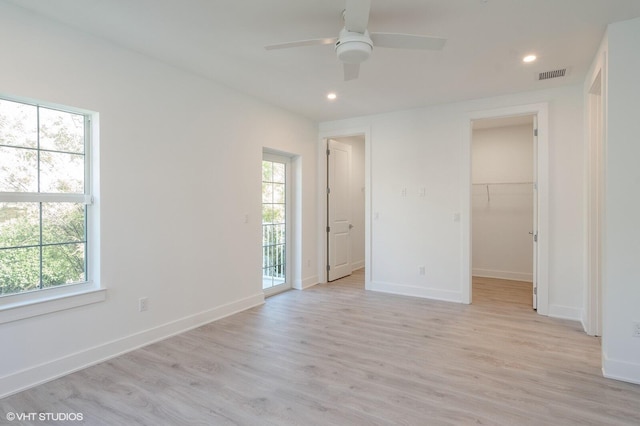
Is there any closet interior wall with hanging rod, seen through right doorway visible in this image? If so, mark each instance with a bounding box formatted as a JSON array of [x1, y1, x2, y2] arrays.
[[471, 124, 533, 281]]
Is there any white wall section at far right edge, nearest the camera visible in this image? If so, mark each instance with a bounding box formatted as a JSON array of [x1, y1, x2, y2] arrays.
[[602, 18, 640, 384]]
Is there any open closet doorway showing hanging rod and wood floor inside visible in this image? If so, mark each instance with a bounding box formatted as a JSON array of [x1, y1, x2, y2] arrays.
[[471, 114, 538, 309]]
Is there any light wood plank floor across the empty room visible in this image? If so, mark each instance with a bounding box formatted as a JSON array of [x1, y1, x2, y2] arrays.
[[0, 271, 640, 426]]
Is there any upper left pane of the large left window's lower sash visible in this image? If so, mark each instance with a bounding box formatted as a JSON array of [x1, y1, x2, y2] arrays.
[[0, 203, 40, 248]]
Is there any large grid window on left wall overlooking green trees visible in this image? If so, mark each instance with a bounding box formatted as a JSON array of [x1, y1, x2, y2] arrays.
[[0, 98, 92, 299]]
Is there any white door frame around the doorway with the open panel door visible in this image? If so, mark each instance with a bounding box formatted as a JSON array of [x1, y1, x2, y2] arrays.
[[317, 127, 373, 290]]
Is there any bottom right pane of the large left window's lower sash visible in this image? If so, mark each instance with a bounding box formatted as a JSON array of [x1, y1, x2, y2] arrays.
[[42, 244, 85, 287]]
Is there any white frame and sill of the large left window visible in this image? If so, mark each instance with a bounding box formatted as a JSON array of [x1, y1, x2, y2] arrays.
[[0, 94, 106, 324]]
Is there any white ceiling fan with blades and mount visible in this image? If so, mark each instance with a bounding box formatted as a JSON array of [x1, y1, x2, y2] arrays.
[[265, 0, 447, 81]]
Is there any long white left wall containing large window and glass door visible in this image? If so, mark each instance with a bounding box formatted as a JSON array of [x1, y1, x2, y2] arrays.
[[0, 2, 318, 397]]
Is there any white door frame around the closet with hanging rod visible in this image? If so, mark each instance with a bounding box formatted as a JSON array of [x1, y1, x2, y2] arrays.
[[460, 102, 549, 315]]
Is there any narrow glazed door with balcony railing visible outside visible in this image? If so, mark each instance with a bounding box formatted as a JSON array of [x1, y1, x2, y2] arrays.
[[262, 154, 290, 294]]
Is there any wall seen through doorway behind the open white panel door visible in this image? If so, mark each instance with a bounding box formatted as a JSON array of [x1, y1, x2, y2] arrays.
[[333, 136, 365, 270]]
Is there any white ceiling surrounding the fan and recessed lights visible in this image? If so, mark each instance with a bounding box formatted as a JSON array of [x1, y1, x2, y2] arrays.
[[4, 0, 640, 121]]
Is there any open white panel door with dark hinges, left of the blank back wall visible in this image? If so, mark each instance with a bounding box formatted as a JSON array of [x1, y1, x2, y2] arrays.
[[327, 139, 352, 281]]
